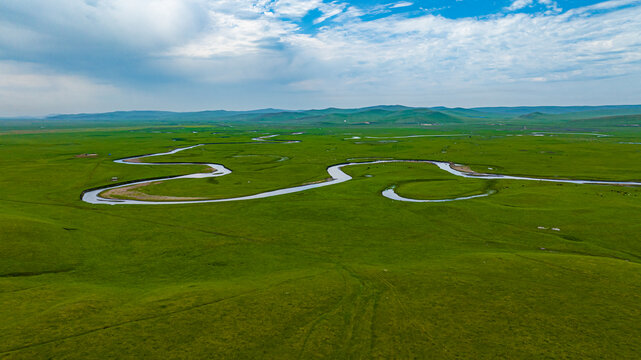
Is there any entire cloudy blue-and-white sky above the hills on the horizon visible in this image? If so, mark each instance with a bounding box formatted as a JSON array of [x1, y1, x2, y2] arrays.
[[0, 0, 641, 117]]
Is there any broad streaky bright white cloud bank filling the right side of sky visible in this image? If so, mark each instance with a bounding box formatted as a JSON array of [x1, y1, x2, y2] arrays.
[[278, 1, 641, 104]]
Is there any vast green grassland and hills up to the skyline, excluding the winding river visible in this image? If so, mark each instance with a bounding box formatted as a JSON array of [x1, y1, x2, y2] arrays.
[[0, 107, 641, 359]]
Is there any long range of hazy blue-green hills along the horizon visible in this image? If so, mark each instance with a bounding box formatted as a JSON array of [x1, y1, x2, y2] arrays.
[[0, 105, 641, 130]]
